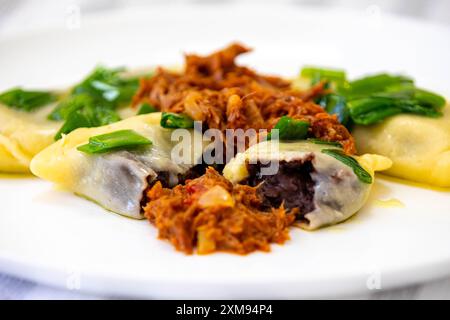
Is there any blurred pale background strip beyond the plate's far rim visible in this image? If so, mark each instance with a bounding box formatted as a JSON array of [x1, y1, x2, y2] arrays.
[[0, 0, 450, 36]]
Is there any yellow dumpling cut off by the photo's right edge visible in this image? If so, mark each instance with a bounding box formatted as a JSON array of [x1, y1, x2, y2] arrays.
[[352, 106, 450, 187]]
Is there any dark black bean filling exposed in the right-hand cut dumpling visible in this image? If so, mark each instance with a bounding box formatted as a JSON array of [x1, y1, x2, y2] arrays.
[[245, 157, 315, 216]]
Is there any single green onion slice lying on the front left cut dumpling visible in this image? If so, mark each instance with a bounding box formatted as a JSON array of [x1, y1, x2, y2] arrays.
[[77, 130, 152, 154]]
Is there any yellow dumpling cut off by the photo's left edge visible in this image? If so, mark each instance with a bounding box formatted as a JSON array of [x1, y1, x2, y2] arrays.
[[0, 104, 61, 173]]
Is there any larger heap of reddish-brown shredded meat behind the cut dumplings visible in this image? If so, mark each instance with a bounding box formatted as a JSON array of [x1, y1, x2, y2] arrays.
[[133, 44, 355, 154]]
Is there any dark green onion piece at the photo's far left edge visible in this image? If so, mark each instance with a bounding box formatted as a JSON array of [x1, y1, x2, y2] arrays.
[[0, 88, 58, 112]]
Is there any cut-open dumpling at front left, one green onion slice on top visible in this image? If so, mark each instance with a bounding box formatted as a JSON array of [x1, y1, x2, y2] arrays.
[[30, 113, 205, 218]]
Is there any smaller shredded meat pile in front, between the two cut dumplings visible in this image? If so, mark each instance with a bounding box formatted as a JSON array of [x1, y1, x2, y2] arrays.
[[144, 167, 295, 254]]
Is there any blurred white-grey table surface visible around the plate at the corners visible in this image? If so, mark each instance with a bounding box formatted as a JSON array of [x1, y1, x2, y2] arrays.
[[0, 0, 450, 299]]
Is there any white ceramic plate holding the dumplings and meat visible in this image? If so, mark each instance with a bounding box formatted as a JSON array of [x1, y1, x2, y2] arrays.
[[0, 5, 450, 298]]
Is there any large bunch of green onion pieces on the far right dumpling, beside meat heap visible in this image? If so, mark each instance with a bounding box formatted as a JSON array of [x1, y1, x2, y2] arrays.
[[301, 68, 446, 128]]
